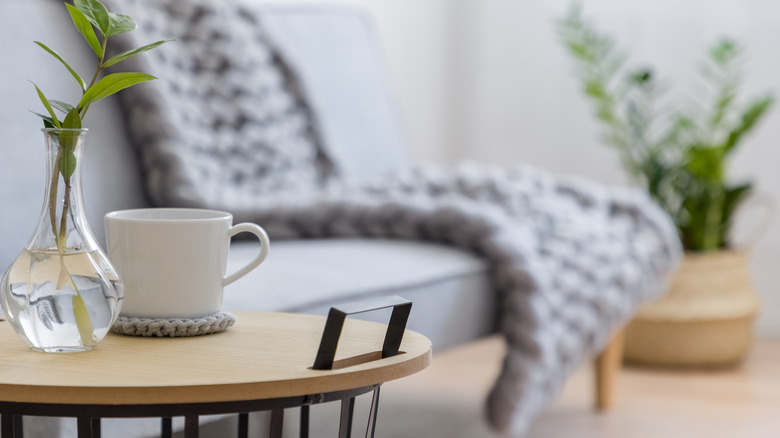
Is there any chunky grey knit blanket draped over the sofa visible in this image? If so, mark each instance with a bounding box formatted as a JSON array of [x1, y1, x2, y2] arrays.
[[106, 0, 680, 432]]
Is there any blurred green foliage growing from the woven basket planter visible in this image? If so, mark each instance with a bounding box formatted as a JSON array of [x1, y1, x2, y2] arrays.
[[558, 6, 774, 251]]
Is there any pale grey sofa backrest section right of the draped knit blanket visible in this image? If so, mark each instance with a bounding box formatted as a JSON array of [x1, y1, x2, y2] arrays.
[[257, 5, 410, 182]]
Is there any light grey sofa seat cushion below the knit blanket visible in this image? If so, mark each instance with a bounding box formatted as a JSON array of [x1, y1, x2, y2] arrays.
[[223, 239, 496, 348]]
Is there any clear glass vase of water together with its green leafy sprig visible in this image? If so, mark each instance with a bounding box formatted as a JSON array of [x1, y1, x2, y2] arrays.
[[0, 0, 171, 352]]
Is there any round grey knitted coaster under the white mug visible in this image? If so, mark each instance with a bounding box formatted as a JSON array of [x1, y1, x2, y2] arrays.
[[111, 312, 236, 338]]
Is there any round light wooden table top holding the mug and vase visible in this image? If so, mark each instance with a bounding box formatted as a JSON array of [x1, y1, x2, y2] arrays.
[[0, 312, 431, 405]]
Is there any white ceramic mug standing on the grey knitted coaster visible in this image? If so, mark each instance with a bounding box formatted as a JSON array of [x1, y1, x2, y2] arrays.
[[105, 208, 270, 318]]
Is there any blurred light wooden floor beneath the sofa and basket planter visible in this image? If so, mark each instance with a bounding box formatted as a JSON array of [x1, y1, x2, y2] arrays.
[[377, 338, 780, 438]]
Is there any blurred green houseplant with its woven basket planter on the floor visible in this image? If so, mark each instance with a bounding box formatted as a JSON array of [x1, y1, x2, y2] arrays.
[[558, 8, 774, 366]]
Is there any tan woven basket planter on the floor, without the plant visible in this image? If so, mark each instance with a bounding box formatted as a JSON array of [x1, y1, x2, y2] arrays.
[[624, 251, 759, 367]]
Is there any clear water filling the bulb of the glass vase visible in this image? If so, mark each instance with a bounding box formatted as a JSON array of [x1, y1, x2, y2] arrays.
[[0, 248, 122, 352]]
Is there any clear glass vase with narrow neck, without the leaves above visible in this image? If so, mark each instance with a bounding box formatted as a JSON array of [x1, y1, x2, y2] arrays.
[[0, 129, 123, 352]]
